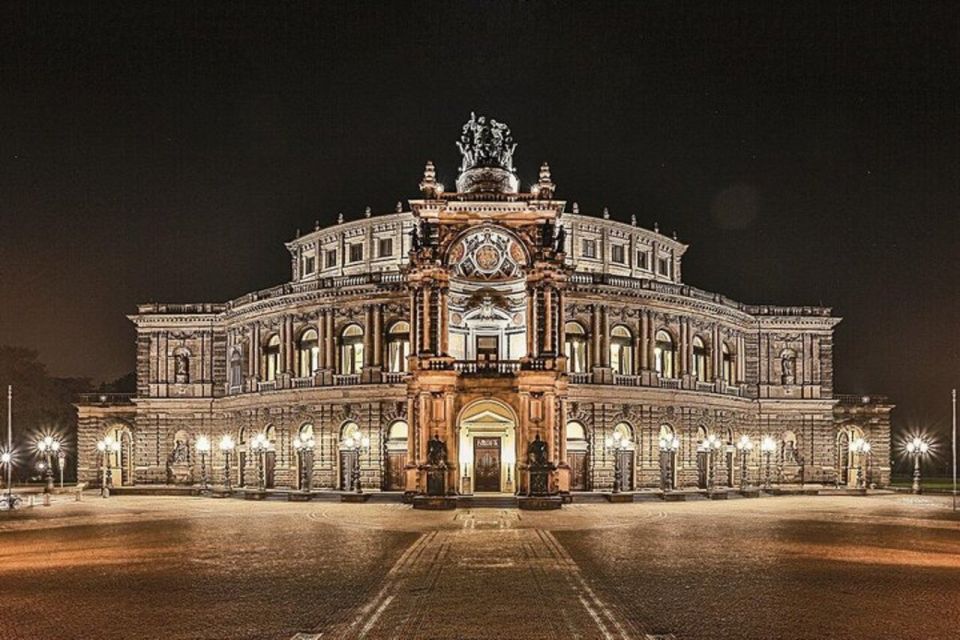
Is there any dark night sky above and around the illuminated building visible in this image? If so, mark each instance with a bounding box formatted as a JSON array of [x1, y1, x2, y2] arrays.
[[0, 2, 960, 438]]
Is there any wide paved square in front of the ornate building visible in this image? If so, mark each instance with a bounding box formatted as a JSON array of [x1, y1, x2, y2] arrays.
[[0, 495, 960, 640]]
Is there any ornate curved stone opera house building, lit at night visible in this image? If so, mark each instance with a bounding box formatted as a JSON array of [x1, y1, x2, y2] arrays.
[[78, 118, 892, 494]]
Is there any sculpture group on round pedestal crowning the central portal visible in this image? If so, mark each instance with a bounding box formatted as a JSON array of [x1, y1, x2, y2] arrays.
[[457, 113, 519, 194]]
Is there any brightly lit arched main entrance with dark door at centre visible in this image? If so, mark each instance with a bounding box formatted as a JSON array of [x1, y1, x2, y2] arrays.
[[457, 400, 517, 493]]
